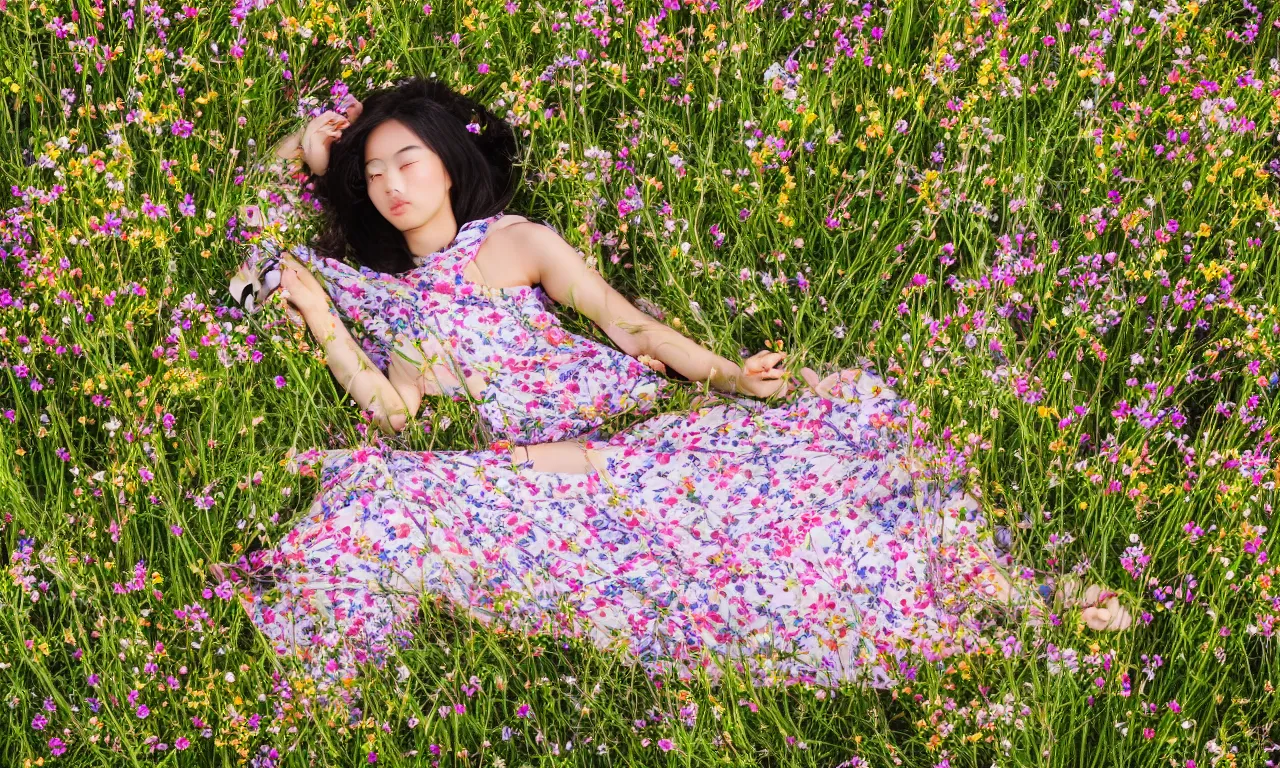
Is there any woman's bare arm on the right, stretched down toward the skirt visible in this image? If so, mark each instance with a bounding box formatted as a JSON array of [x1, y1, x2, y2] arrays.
[[495, 221, 786, 397]]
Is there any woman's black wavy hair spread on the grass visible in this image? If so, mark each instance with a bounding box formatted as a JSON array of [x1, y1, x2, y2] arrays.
[[311, 77, 520, 274]]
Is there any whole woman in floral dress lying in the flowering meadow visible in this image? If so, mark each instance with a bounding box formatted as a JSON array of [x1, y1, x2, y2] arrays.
[[215, 76, 1132, 685]]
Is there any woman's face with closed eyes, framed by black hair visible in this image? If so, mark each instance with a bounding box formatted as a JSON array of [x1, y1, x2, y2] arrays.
[[365, 120, 453, 232]]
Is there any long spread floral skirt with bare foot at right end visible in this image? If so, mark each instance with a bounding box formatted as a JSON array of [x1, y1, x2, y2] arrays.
[[215, 370, 1132, 686]]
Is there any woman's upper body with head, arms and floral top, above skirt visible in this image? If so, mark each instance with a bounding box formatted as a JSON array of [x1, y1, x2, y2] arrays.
[[232, 79, 786, 444]]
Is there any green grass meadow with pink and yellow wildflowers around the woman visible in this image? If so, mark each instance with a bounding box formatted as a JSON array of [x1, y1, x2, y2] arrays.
[[0, 0, 1280, 768]]
